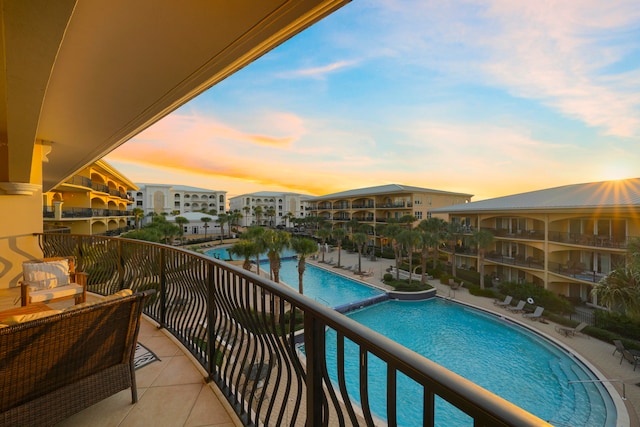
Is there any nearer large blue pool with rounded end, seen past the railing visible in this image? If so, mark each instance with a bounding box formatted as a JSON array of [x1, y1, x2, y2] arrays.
[[327, 298, 616, 426]]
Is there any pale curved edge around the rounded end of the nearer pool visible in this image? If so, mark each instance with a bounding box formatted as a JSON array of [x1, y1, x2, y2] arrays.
[[437, 295, 631, 427]]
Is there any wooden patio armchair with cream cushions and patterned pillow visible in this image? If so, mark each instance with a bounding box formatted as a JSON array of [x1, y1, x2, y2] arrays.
[[20, 257, 88, 306]]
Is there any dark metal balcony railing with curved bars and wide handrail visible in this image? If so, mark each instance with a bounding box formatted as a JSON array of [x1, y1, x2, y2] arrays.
[[39, 234, 549, 427]]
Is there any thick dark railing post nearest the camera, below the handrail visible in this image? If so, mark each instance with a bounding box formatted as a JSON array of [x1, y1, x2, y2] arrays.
[[304, 312, 325, 427]]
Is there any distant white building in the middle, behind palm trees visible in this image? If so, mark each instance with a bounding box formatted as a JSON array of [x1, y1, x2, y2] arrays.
[[229, 191, 311, 227]]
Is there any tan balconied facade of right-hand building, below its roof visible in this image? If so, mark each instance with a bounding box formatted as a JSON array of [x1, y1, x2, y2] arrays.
[[450, 207, 640, 304]]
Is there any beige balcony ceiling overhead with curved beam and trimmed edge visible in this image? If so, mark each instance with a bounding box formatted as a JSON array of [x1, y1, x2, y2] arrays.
[[0, 0, 348, 191]]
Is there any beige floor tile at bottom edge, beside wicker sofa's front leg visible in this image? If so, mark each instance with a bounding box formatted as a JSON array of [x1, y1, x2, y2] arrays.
[[119, 384, 202, 427]]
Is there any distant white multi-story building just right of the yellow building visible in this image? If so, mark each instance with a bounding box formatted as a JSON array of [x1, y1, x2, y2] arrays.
[[130, 184, 227, 221]]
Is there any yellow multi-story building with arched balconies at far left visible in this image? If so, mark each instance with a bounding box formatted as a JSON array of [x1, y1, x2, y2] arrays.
[[42, 160, 138, 235]]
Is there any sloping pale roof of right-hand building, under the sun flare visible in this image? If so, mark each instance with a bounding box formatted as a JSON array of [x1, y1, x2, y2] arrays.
[[432, 178, 640, 213]]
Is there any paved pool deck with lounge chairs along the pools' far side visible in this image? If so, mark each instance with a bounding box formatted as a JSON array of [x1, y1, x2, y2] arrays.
[[309, 250, 640, 426]]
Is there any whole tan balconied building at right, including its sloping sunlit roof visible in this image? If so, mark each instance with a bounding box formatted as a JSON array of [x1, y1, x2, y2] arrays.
[[436, 178, 640, 304]]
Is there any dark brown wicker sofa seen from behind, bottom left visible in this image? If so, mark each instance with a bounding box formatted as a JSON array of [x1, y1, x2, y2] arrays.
[[0, 293, 148, 426]]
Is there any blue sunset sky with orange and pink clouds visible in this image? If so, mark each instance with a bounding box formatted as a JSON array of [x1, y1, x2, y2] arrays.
[[105, 0, 640, 201]]
